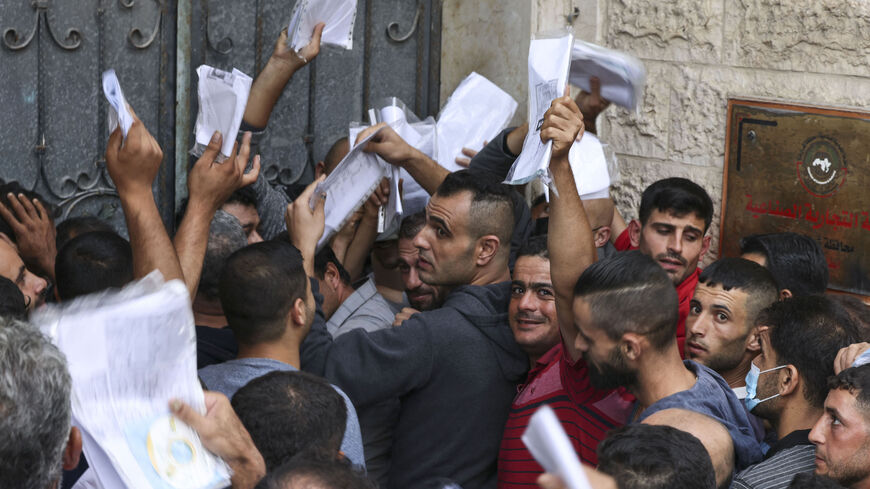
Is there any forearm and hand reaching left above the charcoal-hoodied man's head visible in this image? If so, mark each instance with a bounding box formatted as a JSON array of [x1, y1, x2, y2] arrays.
[[357, 122, 450, 195]]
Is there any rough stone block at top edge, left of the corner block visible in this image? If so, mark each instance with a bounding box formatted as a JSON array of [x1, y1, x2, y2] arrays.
[[605, 0, 725, 63]]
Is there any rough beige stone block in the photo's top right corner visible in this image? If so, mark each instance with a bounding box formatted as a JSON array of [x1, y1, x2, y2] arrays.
[[723, 0, 870, 76]]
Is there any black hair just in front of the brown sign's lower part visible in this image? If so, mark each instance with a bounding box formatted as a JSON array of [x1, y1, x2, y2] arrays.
[[740, 233, 829, 296]]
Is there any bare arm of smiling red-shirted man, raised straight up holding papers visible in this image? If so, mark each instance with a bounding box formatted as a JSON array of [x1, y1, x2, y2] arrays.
[[541, 97, 596, 361]]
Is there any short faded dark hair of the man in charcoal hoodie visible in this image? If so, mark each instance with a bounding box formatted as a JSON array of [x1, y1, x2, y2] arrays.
[[435, 170, 514, 250]]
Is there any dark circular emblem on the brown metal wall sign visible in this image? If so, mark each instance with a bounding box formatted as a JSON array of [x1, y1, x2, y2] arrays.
[[797, 136, 849, 197]]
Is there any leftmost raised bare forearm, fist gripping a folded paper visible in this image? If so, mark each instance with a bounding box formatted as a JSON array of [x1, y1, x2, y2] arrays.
[[106, 109, 184, 280]]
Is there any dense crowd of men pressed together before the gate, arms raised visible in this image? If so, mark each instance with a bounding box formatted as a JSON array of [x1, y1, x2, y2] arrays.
[[0, 27, 870, 489]]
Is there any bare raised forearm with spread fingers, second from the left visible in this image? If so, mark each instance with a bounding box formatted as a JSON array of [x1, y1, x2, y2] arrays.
[[173, 132, 260, 300]]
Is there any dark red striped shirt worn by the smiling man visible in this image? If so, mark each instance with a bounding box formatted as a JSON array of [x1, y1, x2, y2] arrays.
[[498, 343, 634, 489]]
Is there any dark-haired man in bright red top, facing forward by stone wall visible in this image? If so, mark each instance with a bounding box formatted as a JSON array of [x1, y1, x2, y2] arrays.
[[612, 177, 713, 355]]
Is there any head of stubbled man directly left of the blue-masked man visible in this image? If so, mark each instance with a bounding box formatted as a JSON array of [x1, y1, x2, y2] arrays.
[[686, 258, 779, 392]]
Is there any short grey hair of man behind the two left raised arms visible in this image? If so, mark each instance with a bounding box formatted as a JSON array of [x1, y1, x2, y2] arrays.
[[197, 210, 248, 300]]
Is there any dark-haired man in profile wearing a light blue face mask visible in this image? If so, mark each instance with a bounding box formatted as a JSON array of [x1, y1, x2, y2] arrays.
[[731, 296, 858, 489]]
